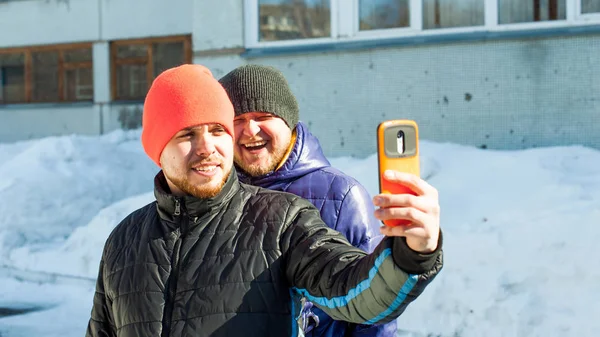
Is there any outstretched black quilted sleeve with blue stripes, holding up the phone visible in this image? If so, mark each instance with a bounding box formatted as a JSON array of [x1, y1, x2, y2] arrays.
[[280, 199, 442, 324]]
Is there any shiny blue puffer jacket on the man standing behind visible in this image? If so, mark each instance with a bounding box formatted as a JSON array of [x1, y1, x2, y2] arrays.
[[238, 122, 396, 337]]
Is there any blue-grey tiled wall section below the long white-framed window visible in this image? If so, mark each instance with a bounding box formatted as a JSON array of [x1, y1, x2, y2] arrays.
[[238, 36, 600, 157]]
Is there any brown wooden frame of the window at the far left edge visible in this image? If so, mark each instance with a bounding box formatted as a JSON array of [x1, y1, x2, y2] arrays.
[[0, 42, 95, 105]]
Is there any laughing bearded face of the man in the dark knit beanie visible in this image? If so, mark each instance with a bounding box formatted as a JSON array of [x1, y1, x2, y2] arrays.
[[233, 112, 292, 177]]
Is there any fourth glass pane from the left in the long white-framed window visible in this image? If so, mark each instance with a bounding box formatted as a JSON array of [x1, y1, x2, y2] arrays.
[[498, 0, 567, 24]]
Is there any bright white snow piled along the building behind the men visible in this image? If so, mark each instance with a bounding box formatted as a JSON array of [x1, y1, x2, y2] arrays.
[[0, 131, 600, 337]]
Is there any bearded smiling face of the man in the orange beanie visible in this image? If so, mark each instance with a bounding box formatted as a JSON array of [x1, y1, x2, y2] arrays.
[[160, 124, 233, 198]]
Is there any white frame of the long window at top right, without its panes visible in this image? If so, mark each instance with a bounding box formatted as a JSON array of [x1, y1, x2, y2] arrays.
[[244, 0, 600, 49]]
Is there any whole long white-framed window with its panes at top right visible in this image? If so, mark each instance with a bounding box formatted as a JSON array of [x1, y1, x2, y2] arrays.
[[244, 0, 600, 48]]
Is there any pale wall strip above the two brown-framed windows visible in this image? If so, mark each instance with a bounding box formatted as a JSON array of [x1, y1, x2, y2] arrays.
[[0, 0, 194, 48]]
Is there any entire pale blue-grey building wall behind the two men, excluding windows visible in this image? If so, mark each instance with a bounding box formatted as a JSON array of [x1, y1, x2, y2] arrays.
[[0, 0, 600, 157]]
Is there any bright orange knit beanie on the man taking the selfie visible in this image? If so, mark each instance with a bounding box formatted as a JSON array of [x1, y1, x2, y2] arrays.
[[142, 64, 234, 167]]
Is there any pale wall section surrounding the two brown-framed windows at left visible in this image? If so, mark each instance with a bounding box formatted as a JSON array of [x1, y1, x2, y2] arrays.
[[0, 0, 194, 141]]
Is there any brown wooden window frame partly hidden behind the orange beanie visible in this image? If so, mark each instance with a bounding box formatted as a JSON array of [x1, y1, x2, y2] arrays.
[[110, 35, 192, 101]]
